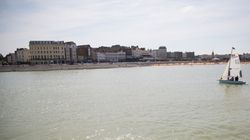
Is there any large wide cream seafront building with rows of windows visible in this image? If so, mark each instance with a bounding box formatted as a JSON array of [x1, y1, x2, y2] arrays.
[[29, 41, 65, 64]]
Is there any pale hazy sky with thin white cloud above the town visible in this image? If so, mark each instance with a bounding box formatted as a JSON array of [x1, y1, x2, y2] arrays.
[[0, 0, 250, 55]]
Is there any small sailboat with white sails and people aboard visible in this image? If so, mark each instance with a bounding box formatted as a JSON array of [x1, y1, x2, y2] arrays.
[[219, 47, 246, 85]]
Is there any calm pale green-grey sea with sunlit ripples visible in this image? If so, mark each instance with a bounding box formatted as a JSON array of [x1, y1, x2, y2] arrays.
[[0, 65, 250, 140]]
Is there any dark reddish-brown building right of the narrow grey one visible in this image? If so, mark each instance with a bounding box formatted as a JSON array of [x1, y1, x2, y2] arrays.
[[77, 45, 92, 62]]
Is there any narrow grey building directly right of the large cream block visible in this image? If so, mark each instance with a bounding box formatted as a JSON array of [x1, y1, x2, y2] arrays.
[[65, 41, 77, 64]]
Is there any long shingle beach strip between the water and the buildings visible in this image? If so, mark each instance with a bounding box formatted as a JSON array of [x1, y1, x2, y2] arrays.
[[0, 61, 250, 72]]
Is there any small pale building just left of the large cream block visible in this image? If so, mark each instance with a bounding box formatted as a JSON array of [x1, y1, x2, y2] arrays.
[[15, 48, 30, 64]]
